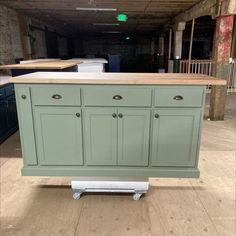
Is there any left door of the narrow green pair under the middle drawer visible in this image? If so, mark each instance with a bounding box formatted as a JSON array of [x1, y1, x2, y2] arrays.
[[85, 108, 117, 165]]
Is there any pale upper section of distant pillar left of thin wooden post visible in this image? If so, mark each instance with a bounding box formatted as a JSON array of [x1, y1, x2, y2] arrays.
[[173, 22, 186, 58]]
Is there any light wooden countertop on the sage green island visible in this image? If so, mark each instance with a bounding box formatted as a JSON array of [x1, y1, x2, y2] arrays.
[[10, 72, 226, 85]]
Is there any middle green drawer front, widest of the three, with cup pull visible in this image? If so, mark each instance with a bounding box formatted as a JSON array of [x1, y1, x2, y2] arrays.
[[84, 87, 151, 107]]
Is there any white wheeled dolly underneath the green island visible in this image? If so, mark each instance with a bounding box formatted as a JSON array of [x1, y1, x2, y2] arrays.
[[71, 177, 149, 201]]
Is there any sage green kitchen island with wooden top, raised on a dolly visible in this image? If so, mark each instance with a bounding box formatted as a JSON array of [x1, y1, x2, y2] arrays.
[[11, 72, 226, 178]]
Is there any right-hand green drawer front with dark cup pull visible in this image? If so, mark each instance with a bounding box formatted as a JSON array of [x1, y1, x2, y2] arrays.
[[154, 88, 204, 107]]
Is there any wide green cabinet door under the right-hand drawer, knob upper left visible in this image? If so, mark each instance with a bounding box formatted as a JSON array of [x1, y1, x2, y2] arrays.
[[152, 109, 201, 167]]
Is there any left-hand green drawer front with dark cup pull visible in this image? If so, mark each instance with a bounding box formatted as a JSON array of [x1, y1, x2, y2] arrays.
[[32, 86, 81, 106]]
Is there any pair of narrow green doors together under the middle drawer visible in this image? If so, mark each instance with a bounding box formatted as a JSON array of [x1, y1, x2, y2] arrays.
[[84, 108, 150, 166]]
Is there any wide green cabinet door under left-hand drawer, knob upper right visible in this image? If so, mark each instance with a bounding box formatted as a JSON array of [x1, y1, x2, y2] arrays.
[[35, 106, 83, 166]]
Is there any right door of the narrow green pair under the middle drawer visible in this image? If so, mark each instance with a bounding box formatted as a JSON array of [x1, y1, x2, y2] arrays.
[[118, 109, 150, 166]]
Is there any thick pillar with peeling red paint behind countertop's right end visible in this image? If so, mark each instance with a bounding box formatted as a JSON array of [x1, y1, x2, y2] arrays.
[[209, 16, 234, 120]]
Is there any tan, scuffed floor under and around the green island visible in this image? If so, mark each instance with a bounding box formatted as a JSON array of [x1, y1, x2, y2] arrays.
[[0, 94, 236, 236]]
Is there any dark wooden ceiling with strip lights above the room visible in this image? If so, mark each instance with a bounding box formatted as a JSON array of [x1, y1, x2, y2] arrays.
[[0, 0, 199, 33]]
